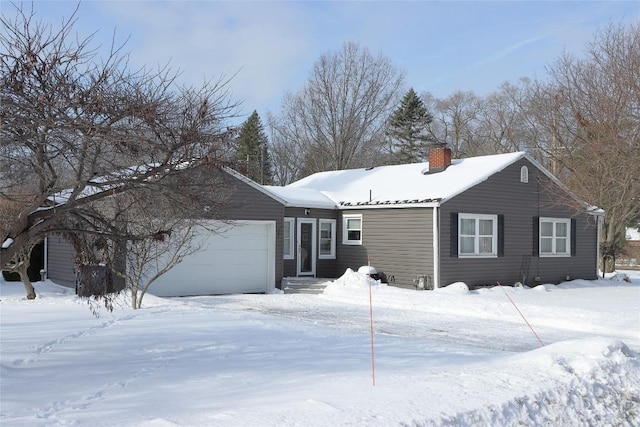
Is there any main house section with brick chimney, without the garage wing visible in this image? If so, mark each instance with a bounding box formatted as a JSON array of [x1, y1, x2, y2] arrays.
[[269, 148, 601, 289]]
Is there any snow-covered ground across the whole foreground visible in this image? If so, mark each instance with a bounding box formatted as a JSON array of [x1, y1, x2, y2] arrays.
[[0, 271, 640, 427]]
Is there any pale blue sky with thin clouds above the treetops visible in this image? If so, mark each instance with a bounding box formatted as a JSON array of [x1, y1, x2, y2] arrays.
[[8, 0, 640, 120]]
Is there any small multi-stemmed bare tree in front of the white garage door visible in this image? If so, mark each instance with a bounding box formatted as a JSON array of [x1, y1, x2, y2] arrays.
[[112, 182, 230, 309]]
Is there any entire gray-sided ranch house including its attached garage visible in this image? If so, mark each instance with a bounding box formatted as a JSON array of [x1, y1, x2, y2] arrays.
[[47, 148, 601, 296]]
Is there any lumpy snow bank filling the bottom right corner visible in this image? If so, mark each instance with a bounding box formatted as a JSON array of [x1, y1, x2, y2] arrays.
[[430, 338, 640, 426]]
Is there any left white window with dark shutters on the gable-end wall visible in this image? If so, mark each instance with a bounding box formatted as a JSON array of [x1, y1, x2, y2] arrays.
[[458, 213, 498, 257]]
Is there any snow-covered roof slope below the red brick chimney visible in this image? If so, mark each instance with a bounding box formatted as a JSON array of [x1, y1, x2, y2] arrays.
[[268, 152, 526, 208]]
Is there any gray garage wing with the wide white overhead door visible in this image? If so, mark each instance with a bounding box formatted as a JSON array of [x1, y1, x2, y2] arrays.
[[45, 167, 284, 296]]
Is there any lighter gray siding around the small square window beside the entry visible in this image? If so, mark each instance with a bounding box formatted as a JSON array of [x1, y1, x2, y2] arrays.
[[337, 208, 433, 287]]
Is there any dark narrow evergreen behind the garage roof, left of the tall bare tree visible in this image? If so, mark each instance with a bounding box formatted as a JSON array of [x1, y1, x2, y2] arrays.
[[235, 110, 273, 185]]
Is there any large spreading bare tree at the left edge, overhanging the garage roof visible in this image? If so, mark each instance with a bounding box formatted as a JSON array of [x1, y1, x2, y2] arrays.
[[0, 6, 235, 298]]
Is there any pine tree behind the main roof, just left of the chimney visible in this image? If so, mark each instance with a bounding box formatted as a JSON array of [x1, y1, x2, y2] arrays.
[[387, 88, 435, 163]]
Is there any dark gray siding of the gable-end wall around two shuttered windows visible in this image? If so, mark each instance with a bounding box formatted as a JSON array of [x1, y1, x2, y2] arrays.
[[439, 159, 597, 286]]
